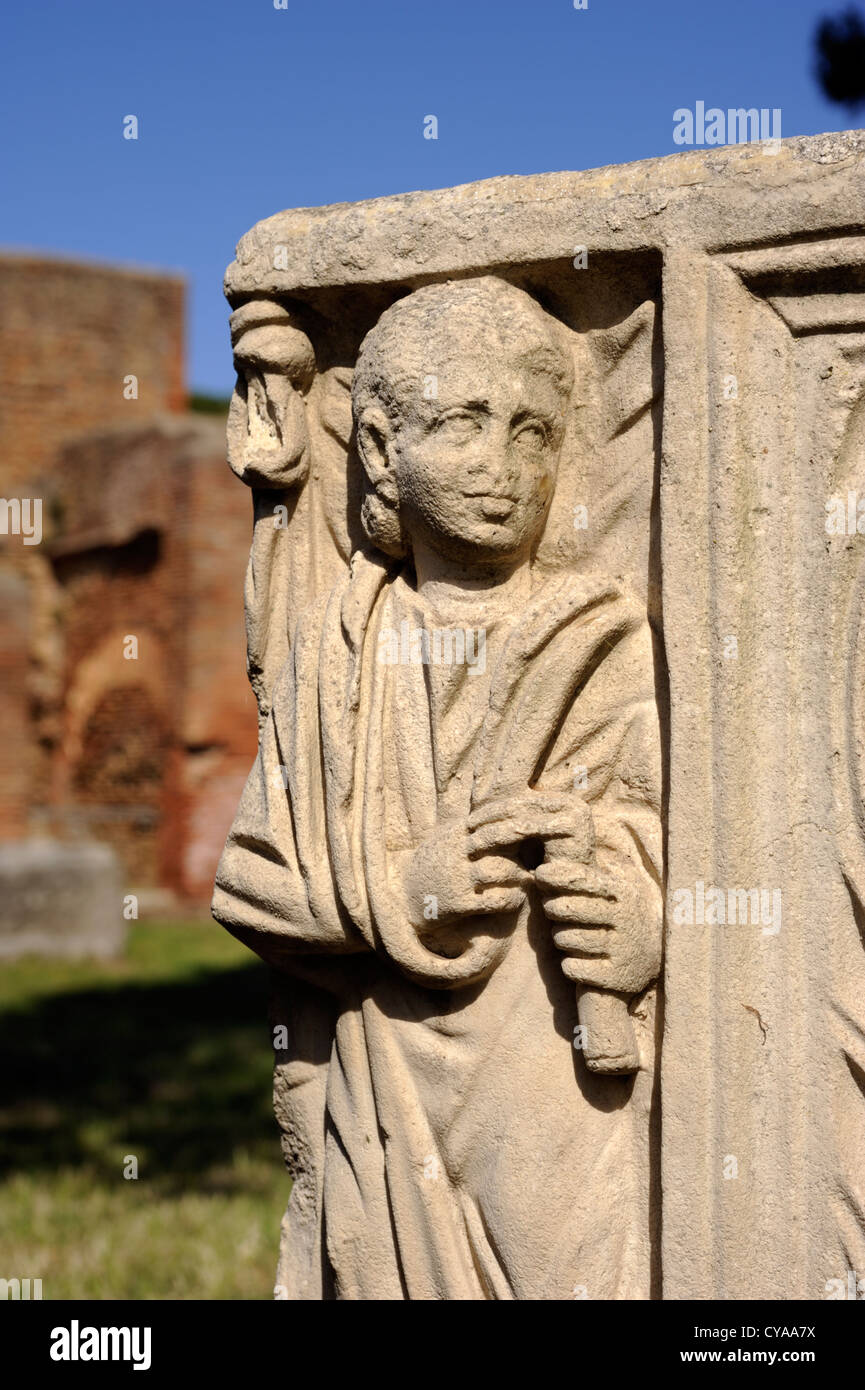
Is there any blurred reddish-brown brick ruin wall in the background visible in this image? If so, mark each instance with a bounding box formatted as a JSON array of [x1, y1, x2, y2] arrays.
[[0, 257, 256, 901]]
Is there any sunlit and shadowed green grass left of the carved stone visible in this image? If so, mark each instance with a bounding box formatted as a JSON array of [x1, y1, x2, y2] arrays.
[[0, 923, 289, 1298]]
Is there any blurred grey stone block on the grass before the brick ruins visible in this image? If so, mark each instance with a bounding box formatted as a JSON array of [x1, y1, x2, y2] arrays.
[[0, 840, 127, 960]]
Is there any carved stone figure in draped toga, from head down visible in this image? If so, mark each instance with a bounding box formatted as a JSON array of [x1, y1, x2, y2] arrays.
[[213, 278, 662, 1298]]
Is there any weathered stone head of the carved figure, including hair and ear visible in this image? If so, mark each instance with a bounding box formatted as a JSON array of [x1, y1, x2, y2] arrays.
[[352, 277, 573, 566]]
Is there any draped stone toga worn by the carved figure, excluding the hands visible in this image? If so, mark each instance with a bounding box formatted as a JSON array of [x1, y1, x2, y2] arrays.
[[213, 552, 662, 1300]]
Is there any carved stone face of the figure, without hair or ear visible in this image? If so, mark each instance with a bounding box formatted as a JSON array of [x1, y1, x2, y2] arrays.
[[388, 353, 563, 566]]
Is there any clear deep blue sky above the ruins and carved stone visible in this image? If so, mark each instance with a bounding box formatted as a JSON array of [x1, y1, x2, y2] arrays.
[[0, 0, 865, 393]]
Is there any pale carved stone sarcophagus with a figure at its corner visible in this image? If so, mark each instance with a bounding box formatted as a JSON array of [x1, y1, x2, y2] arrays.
[[214, 132, 865, 1300]]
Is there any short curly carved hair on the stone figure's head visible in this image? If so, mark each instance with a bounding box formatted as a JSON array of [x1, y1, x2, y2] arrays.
[[352, 275, 574, 556]]
